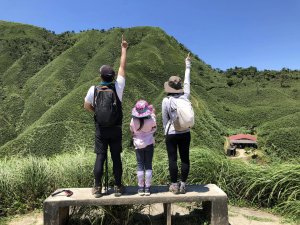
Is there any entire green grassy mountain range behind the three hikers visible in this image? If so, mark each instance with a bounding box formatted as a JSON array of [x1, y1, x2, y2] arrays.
[[0, 21, 300, 160]]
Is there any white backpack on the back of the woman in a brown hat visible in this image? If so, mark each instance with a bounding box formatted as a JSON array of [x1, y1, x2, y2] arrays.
[[170, 97, 195, 131]]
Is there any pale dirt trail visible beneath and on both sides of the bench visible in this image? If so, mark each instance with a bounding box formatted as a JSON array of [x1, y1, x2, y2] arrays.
[[8, 204, 291, 225]]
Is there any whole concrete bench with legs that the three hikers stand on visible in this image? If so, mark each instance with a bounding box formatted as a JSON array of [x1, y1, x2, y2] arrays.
[[44, 184, 228, 225]]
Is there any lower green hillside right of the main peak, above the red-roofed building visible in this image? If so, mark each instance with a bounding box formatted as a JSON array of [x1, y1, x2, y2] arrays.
[[208, 76, 300, 161]]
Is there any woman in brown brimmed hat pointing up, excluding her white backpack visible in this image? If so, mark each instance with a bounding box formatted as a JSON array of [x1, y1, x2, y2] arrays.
[[162, 53, 191, 194]]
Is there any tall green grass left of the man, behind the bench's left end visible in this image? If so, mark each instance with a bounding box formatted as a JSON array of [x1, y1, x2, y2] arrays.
[[0, 149, 93, 215]]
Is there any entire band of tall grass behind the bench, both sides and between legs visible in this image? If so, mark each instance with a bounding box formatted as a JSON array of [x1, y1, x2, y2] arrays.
[[0, 148, 300, 220]]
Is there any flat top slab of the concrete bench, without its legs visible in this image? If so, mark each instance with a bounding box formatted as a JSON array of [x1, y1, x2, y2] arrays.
[[45, 184, 227, 207]]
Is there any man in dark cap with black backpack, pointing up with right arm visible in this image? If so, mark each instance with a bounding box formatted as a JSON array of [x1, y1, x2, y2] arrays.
[[84, 35, 128, 198]]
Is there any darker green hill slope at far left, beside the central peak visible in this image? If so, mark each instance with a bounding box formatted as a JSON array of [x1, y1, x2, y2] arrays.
[[0, 21, 74, 145]]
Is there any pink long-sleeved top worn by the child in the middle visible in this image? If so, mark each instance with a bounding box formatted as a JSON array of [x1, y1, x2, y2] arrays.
[[130, 114, 156, 149]]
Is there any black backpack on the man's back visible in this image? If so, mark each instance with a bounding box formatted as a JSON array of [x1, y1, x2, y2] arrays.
[[94, 85, 122, 127]]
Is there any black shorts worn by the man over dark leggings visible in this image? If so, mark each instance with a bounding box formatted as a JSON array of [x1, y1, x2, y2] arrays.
[[95, 124, 122, 154]]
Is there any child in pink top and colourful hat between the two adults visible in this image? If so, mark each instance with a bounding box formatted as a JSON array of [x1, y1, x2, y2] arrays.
[[130, 100, 156, 196]]
